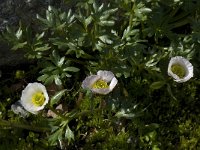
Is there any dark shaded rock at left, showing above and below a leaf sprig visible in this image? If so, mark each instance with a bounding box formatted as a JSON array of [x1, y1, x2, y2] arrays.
[[0, 0, 61, 67]]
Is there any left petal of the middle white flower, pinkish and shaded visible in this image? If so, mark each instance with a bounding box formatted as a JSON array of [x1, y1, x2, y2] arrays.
[[82, 75, 101, 89]]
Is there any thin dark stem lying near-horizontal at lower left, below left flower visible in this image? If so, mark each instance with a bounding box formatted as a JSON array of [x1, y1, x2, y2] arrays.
[[0, 119, 51, 132]]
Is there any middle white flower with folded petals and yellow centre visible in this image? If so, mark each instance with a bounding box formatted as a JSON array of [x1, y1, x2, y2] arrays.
[[82, 70, 118, 95]]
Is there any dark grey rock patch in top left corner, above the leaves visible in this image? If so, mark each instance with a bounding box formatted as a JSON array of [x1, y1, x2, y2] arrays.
[[0, 0, 64, 31]]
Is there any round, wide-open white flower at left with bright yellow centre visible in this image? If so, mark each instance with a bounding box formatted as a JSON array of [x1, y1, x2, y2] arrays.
[[20, 82, 49, 114]]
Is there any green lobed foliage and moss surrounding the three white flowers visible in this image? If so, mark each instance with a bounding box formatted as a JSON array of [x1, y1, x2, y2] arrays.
[[0, 0, 200, 150]]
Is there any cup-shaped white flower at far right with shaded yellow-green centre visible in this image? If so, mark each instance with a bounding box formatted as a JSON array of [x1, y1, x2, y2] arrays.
[[168, 56, 193, 83]]
